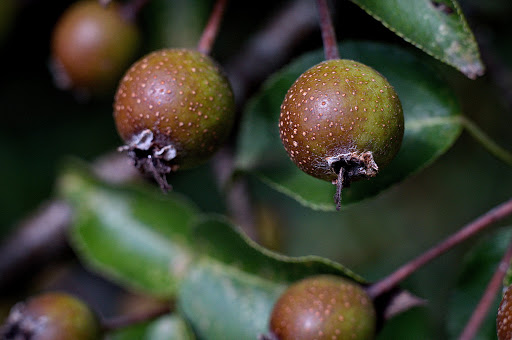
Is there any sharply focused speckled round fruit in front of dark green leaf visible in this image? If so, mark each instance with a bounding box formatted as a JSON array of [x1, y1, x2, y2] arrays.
[[279, 59, 404, 209]]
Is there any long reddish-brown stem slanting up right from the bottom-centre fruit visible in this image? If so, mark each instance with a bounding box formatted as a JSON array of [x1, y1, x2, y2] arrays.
[[367, 199, 512, 298]]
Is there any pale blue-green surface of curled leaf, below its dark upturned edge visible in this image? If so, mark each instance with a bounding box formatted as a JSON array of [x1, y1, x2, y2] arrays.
[[178, 261, 285, 340]]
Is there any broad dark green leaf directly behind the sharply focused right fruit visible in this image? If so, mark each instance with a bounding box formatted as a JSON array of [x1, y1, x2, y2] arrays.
[[236, 42, 462, 210]]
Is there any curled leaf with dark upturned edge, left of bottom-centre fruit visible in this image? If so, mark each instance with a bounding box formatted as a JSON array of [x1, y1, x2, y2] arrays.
[[178, 217, 374, 340]]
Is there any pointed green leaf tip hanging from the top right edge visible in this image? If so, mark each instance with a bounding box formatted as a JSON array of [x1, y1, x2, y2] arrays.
[[352, 0, 484, 79]]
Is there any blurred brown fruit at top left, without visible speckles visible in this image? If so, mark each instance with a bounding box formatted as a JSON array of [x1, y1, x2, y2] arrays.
[[51, 0, 140, 93]]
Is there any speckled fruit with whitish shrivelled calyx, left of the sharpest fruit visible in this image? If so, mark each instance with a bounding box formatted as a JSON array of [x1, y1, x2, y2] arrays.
[[114, 49, 235, 190]]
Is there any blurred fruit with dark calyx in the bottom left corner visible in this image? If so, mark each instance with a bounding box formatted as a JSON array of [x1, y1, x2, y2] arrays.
[[0, 292, 101, 340]]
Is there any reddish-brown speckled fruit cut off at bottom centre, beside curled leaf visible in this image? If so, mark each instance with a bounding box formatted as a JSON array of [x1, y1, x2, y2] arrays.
[[270, 275, 376, 340]]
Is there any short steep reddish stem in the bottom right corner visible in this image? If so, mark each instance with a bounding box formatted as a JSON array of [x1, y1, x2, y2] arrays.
[[459, 234, 512, 340]]
